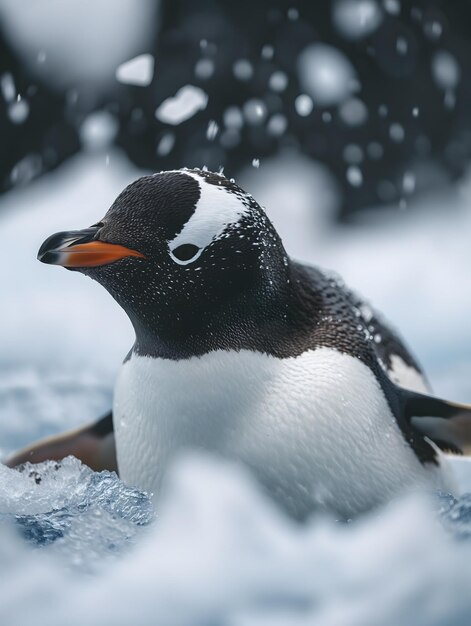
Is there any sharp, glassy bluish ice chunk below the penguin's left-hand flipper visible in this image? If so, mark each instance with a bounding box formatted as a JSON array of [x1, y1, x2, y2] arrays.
[[0, 457, 153, 571]]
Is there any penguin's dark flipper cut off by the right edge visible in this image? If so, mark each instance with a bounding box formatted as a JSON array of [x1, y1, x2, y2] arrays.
[[401, 390, 471, 455]]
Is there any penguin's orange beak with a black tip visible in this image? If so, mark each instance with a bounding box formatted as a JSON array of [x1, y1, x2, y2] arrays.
[[38, 226, 146, 268]]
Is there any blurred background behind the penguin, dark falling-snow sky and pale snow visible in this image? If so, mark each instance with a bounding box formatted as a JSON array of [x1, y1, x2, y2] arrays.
[[0, 0, 471, 451]]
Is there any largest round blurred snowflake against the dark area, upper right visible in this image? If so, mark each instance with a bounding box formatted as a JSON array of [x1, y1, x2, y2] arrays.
[[297, 43, 356, 106]]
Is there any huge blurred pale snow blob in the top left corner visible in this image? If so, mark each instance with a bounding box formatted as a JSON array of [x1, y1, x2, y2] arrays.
[[0, 0, 155, 94]]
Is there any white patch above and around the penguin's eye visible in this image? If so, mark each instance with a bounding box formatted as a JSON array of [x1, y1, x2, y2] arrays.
[[168, 172, 247, 265]]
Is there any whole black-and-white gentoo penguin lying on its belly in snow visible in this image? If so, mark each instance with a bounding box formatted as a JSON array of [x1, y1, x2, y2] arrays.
[[10, 169, 471, 519]]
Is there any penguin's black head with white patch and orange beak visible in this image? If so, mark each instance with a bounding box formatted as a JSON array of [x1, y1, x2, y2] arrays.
[[38, 170, 288, 354]]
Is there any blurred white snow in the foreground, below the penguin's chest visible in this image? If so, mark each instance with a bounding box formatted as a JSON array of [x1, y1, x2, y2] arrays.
[[0, 457, 471, 626]]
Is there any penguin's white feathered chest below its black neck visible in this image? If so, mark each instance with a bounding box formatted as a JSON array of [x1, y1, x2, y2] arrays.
[[113, 348, 450, 516]]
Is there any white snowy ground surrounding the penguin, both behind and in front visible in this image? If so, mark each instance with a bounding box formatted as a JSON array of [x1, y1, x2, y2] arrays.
[[0, 151, 471, 626]]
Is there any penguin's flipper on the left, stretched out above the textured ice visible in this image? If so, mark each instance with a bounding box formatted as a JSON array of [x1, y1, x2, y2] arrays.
[[6, 412, 118, 472]]
